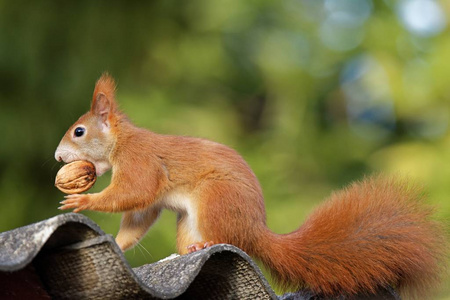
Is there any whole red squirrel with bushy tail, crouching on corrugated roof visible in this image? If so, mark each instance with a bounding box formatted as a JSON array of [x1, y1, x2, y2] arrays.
[[55, 74, 446, 297]]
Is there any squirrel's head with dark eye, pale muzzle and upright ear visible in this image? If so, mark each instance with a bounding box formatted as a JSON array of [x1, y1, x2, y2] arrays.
[[55, 73, 120, 176]]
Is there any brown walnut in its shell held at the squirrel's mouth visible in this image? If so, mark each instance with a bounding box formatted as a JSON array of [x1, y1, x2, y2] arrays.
[[55, 160, 97, 194]]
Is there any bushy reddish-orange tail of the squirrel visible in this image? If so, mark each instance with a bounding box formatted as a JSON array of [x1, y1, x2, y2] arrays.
[[258, 177, 447, 298]]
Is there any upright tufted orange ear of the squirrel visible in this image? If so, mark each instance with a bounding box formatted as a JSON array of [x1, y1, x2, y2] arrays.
[[91, 73, 116, 122]]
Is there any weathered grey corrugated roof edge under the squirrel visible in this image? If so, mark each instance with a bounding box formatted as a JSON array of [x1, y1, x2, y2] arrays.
[[0, 213, 395, 300]]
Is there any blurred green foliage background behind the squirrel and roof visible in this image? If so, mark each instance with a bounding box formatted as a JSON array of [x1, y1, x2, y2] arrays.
[[0, 0, 450, 299]]
